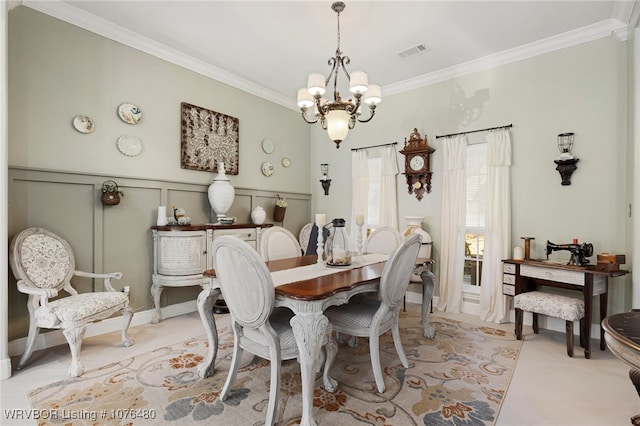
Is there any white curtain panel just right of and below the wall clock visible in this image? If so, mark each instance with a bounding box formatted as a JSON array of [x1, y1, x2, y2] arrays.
[[438, 135, 467, 313]]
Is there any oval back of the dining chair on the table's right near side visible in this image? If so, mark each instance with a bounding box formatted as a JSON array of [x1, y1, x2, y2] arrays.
[[379, 234, 422, 309]]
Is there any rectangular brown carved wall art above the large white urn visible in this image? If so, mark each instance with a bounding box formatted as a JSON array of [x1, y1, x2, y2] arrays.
[[180, 102, 240, 175]]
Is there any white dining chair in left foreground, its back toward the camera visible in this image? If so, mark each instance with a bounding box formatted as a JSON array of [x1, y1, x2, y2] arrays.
[[213, 235, 337, 425]]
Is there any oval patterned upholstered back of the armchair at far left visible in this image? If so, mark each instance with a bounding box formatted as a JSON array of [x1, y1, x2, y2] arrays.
[[9, 228, 76, 290]]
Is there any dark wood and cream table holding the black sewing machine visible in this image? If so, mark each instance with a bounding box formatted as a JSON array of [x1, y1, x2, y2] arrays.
[[502, 259, 629, 358]]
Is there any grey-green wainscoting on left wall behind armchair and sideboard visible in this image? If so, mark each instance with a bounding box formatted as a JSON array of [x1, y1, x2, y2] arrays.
[[7, 168, 311, 341]]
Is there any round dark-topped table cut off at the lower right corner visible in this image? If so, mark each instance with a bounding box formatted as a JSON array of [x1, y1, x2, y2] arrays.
[[602, 310, 640, 425]]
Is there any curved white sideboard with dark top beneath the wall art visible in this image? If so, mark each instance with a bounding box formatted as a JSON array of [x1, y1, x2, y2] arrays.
[[151, 224, 273, 324]]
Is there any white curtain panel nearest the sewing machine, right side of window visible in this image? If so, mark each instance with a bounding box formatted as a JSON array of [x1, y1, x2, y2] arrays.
[[480, 129, 511, 322]]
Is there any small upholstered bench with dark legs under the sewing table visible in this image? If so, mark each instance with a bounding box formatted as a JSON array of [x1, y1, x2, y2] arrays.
[[513, 291, 585, 357]]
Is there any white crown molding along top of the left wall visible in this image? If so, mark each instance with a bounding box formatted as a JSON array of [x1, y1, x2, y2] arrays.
[[22, 0, 298, 111]]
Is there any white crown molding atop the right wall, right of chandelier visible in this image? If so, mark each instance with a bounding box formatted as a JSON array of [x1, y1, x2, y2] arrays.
[[383, 19, 627, 95]]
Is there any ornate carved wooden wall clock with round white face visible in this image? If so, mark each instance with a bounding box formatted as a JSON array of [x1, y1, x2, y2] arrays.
[[400, 129, 435, 201]]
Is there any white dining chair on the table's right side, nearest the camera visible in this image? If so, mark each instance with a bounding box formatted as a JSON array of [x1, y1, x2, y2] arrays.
[[325, 234, 422, 393]]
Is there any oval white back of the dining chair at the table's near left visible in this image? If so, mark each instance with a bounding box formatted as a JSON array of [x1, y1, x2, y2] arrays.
[[213, 235, 276, 328]]
